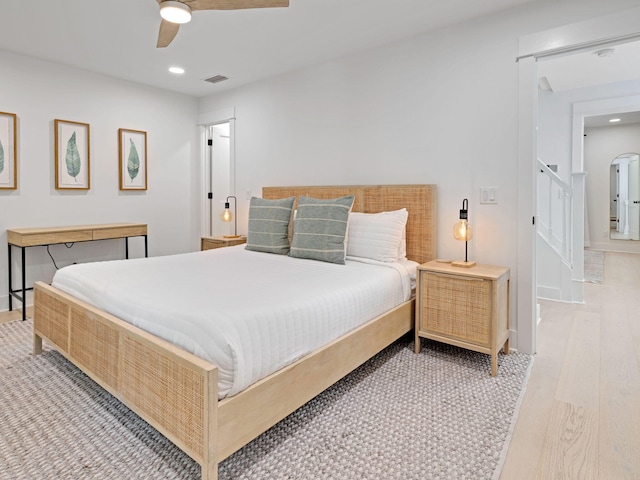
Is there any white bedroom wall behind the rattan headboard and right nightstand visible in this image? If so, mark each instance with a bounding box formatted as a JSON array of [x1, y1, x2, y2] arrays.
[[199, 0, 637, 346]]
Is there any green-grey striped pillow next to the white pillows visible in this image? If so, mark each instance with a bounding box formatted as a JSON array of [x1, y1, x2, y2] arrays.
[[289, 195, 355, 264]]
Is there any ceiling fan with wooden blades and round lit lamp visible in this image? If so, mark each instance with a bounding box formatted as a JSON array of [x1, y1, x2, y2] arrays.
[[156, 0, 289, 48]]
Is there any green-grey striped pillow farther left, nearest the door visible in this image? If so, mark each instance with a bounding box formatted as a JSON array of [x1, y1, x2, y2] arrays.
[[245, 197, 296, 255]]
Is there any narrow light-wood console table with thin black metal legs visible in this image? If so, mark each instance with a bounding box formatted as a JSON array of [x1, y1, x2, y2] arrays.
[[7, 223, 149, 320]]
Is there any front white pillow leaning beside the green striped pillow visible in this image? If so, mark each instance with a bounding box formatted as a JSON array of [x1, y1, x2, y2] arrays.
[[347, 208, 409, 262]]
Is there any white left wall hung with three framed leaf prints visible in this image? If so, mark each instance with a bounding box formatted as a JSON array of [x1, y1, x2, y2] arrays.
[[0, 51, 200, 310]]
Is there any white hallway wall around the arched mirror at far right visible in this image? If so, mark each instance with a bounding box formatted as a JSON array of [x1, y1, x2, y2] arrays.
[[584, 124, 640, 253]]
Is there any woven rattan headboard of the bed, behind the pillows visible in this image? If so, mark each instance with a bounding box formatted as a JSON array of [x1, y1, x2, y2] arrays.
[[262, 185, 436, 263]]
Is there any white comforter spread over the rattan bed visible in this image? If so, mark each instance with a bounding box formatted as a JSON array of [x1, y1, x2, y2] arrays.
[[53, 245, 411, 398]]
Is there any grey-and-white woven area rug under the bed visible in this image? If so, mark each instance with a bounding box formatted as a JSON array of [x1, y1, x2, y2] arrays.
[[0, 320, 532, 480]]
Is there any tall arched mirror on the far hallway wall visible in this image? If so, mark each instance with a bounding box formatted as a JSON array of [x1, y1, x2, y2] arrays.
[[609, 153, 640, 240]]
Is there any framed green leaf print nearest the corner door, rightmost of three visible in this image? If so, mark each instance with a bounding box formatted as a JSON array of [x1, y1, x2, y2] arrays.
[[118, 128, 147, 190]]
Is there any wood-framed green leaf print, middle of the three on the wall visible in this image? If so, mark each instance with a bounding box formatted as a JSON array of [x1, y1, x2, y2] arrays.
[[54, 119, 91, 190]]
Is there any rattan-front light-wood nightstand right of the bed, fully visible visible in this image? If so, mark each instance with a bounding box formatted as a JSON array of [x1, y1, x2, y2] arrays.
[[415, 260, 509, 376]]
